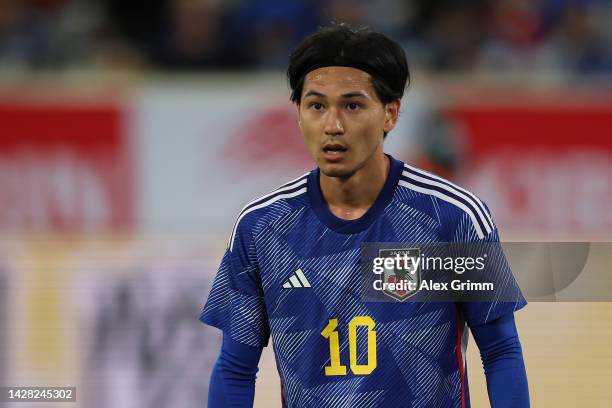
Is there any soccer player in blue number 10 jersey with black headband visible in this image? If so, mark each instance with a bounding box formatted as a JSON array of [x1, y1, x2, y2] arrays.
[[200, 25, 529, 408]]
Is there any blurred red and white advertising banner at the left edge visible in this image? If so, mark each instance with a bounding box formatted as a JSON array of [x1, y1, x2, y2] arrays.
[[0, 101, 134, 231]]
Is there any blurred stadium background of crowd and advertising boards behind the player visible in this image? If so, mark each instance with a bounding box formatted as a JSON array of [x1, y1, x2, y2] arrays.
[[0, 0, 612, 408]]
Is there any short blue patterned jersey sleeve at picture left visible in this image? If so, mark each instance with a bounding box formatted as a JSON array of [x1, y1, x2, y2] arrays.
[[200, 217, 270, 347]]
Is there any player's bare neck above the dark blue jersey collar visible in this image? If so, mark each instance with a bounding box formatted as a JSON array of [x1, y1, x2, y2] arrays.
[[319, 152, 391, 220]]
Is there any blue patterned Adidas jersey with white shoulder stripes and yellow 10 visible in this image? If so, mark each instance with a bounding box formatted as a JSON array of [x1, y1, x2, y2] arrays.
[[200, 158, 526, 408]]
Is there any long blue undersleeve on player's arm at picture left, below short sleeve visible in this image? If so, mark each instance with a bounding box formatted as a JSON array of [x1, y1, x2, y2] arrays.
[[208, 334, 263, 408]]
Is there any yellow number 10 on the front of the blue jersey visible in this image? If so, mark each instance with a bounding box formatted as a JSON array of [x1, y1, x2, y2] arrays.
[[321, 316, 376, 376]]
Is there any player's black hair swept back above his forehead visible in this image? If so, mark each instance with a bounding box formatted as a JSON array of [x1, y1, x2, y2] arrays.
[[287, 24, 410, 105]]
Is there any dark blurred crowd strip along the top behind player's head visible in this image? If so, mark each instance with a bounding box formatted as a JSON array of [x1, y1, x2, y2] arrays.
[[0, 0, 612, 76]]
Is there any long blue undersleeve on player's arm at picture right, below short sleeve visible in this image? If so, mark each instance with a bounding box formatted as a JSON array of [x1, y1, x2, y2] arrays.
[[471, 313, 529, 408]]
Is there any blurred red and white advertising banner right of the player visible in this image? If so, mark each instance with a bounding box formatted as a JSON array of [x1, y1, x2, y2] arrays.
[[448, 95, 612, 233]]
